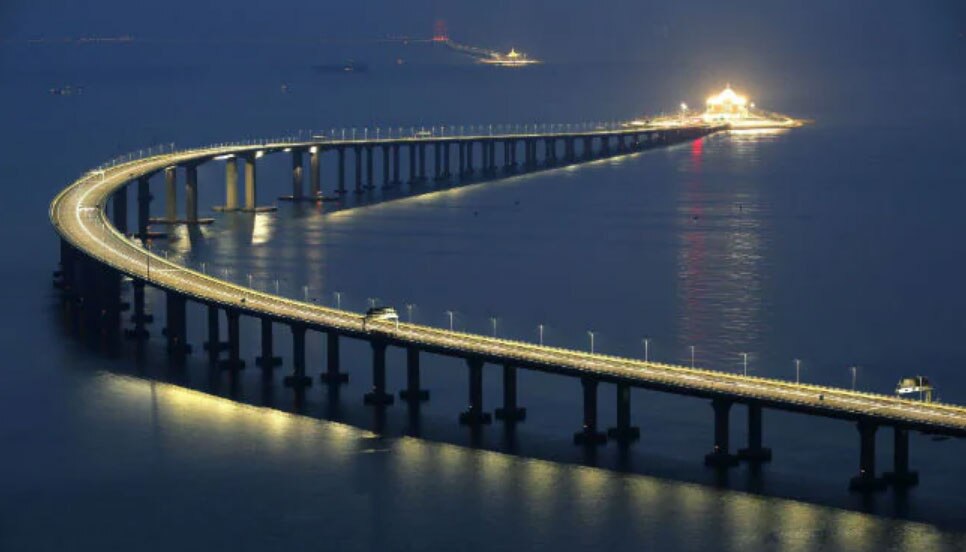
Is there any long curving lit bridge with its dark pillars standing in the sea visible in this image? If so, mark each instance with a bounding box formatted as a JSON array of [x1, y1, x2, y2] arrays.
[[50, 122, 966, 491]]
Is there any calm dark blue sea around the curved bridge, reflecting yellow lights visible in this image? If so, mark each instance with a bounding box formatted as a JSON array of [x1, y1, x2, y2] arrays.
[[0, 3, 966, 551]]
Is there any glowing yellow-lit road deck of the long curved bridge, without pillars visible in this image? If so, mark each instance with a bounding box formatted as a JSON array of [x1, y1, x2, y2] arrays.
[[49, 134, 966, 437]]
